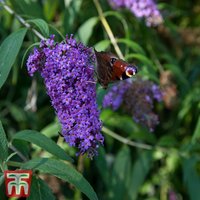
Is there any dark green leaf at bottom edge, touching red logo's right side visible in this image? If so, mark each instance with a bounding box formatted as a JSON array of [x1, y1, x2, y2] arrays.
[[27, 176, 55, 200]]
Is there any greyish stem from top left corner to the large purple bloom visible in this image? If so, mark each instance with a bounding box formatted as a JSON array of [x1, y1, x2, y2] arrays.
[[1, 1, 46, 40]]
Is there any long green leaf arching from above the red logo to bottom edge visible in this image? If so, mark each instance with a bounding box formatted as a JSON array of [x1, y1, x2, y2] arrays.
[[22, 158, 98, 200]]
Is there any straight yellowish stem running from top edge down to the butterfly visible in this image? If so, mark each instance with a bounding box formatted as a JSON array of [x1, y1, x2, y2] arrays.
[[93, 0, 124, 59]]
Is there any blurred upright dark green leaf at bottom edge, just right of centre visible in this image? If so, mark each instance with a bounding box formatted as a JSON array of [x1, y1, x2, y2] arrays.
[[109, 146, 131, 200]]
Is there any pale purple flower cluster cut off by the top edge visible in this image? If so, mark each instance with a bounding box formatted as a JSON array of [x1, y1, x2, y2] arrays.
[[109, 0, 163, 26]]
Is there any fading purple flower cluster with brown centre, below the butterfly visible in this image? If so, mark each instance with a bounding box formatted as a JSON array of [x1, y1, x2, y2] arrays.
[[103, 79, 162, 131]]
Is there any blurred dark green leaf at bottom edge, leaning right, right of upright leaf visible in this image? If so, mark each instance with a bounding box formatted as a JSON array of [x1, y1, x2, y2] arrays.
[[128, 151, 153, 200]]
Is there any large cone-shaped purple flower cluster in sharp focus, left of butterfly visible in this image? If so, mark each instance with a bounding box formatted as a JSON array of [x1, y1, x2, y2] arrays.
[[27, 36, 104, 158]]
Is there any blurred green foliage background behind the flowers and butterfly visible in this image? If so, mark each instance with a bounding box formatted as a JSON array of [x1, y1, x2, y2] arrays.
[[0, 0, 200, 200]]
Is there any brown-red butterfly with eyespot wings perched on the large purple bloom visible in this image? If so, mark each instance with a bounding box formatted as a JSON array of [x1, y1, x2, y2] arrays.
[[94, 49, 138, 89]]
